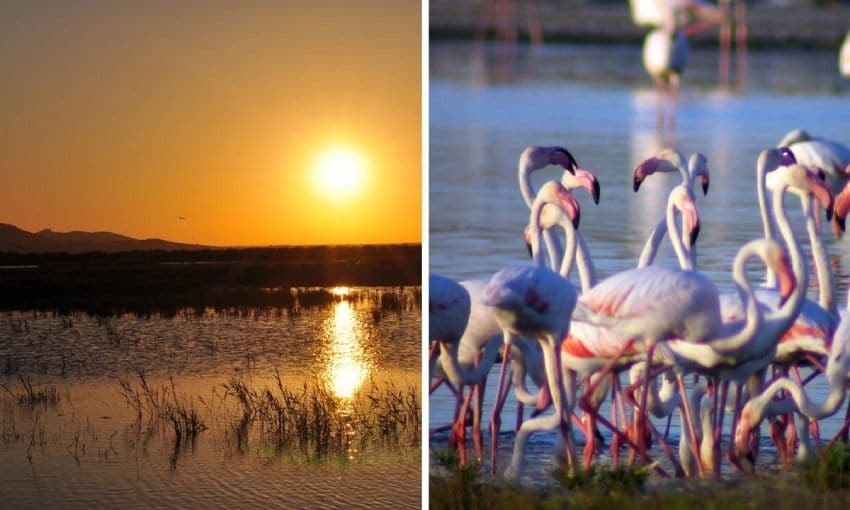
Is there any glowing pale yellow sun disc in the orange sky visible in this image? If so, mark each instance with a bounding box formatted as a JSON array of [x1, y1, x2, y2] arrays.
[[315, 146, 366, 199]]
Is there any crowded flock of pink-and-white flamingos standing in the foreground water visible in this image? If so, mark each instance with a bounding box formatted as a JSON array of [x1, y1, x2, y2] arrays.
[[428, 140, 850, 480]]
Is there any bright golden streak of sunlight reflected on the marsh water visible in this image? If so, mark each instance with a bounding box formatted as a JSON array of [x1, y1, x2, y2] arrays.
[[325, 300, 369, 399]]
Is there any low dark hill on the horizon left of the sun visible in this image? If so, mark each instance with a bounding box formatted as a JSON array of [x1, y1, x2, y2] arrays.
[[0, 223, 210, 253]]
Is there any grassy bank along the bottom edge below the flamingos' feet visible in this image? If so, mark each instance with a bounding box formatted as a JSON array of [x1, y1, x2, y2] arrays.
[[429, 443, 850, 510]]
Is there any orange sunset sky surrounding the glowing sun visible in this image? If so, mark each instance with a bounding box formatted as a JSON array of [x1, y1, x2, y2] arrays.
[[0, 0, 421, 245]]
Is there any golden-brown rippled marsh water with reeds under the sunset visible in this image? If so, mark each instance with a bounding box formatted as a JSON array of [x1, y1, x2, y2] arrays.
[[0, 287, 421, 508]]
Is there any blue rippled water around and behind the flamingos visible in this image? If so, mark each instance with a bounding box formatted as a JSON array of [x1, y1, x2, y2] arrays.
[[429, 42, 850, 482]]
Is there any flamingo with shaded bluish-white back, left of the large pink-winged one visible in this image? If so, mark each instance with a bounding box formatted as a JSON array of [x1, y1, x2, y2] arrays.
[[485, 181, 577, 479]]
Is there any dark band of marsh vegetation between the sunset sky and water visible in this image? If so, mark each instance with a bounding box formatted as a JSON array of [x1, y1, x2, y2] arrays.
[[0, 244, 422, 316]]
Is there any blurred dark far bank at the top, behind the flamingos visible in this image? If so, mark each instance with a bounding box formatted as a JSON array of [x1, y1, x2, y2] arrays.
[[428, 0, 850, 49]]
